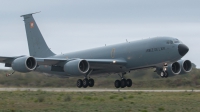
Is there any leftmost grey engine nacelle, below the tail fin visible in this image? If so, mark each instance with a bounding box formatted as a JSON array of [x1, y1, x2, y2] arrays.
[[12, 56, 37, 72]]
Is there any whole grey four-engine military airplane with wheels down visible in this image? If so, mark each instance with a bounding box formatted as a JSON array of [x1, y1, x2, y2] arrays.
[[0, 13, 192, 88]]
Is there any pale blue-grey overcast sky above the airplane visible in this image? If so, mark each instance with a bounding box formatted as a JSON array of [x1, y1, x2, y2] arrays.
[[0, 0, 200, 69]]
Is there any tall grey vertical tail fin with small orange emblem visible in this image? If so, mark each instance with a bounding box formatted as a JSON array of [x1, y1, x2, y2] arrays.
[[21, 13, 55, 58]]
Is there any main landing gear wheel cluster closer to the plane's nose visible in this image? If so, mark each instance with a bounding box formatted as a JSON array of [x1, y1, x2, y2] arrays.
[[114, 73, 132, 88]]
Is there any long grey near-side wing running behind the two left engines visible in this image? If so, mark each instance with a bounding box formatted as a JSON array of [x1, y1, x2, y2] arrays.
[[0, 55, 127, 69]]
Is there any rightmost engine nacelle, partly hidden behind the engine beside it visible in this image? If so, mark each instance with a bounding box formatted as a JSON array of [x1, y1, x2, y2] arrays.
[[178, 60, 192, 74]]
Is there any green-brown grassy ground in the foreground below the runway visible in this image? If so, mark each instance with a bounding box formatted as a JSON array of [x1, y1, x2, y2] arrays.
[[0, 89, 200, 112]]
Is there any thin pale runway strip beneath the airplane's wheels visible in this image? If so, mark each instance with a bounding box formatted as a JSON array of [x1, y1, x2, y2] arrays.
[[0, 88, 200, 92]]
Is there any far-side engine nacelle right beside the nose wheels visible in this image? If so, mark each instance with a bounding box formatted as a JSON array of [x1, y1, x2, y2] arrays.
[[167, 62, 181, 76]]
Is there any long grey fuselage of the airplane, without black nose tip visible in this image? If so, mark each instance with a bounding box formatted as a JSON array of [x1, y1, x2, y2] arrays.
[[37, 37, 186, 76]]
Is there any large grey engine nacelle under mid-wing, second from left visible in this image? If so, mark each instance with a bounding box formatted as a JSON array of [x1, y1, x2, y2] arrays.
[[64, 59, 90, 76]]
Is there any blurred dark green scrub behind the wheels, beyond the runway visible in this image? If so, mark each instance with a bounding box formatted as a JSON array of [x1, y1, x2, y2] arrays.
[[0, 68, 200, 89]]
